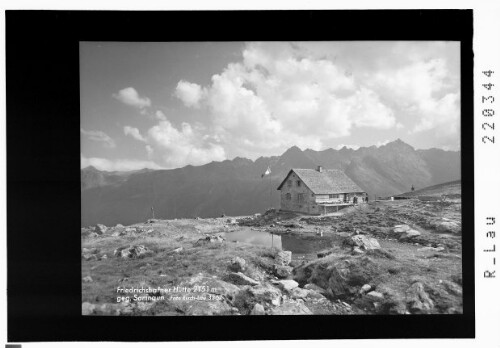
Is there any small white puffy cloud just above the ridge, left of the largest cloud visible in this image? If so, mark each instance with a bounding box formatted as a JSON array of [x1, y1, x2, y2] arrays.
[[148, 120, 226, 168]]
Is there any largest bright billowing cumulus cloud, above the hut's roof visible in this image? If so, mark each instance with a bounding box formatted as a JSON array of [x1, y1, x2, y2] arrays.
[[172, 43, 397, 157]]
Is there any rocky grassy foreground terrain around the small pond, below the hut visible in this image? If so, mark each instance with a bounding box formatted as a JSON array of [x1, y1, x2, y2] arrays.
[[82, 199, 462, 315]]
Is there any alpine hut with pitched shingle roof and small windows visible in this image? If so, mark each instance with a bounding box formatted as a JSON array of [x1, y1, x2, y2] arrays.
[[278, 166, 367, 215]]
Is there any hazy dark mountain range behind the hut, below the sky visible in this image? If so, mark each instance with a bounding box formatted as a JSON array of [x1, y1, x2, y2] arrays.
[[81, 139, 460, 226]]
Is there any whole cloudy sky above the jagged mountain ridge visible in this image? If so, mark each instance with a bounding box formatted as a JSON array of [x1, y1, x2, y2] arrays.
[[80, 41, 460, 171]]
